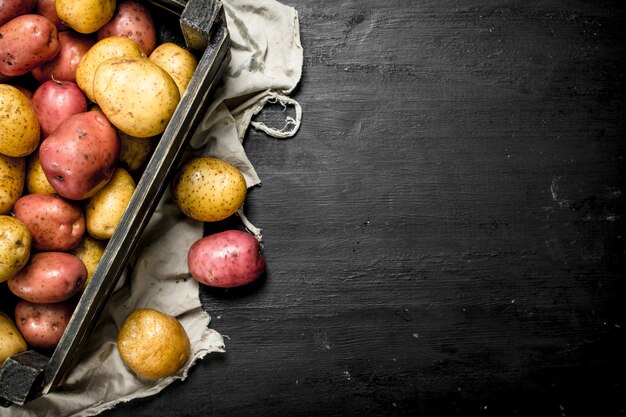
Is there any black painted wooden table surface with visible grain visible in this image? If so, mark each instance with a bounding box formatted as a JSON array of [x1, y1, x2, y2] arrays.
[[100, 0, 626, 417]]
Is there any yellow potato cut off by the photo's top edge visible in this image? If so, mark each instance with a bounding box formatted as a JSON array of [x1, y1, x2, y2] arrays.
[[54, 0, 115, 34]]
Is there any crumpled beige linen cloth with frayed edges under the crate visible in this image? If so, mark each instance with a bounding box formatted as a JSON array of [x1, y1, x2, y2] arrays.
[[0, 0, 303, 417]]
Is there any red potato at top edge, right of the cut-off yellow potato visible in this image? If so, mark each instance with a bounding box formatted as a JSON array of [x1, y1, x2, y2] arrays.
[[96, 0, 157, 55]]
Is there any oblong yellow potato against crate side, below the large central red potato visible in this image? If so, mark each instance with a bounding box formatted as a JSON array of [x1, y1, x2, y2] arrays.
[[85, 167, 135, 239]]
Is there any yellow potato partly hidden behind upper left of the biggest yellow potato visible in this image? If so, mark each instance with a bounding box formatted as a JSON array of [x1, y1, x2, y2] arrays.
[[76, 36, 146, 102]]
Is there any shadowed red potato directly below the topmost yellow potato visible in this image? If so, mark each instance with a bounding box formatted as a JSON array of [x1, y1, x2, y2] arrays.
[[31, 30, 96, 83]]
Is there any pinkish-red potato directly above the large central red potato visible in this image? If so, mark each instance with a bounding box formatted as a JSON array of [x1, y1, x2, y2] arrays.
[[32, 80, 88, 138]]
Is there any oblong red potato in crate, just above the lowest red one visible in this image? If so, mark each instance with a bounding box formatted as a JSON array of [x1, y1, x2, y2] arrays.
[[7, 252, 87, 304]]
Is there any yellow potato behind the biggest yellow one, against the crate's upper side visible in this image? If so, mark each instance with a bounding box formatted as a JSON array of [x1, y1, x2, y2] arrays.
[[149, 42, 198, 97]]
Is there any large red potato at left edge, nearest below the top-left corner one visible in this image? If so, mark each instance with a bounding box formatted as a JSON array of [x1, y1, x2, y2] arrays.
[[0, 14, 59, 76]]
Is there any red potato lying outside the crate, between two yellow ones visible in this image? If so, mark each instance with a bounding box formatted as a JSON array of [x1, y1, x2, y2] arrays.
[[187, 230, 266, 288]]
